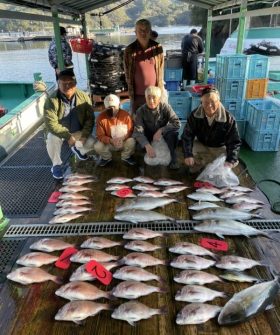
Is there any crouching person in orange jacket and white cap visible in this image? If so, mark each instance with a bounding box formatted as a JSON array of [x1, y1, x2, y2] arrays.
[[94, 94, 135, 166]]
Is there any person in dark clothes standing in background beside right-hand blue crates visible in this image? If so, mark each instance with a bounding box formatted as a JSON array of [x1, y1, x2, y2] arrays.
[[181, 29, 203, 89]]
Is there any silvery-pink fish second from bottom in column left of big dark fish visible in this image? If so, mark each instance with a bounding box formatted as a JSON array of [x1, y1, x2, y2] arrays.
[[175, 285, 227, 302]]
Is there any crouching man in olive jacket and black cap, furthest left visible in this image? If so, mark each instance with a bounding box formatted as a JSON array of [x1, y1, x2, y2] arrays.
[[44, 69, 95, 179]]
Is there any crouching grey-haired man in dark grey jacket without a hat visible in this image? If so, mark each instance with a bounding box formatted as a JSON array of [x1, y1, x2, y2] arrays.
[[133, 86, 180, 170]]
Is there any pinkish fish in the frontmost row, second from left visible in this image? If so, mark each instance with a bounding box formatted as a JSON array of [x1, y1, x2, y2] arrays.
[[111, 301, 166, 326]]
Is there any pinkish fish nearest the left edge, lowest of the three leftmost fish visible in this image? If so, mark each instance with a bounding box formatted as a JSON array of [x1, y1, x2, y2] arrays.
[[7, 267, 62, 285]]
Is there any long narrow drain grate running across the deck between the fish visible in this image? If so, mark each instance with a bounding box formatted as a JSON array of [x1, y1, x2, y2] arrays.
[[4, 220, 280, 238]]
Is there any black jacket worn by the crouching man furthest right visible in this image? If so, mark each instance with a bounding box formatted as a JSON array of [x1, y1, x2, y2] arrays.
[[181, 104, 241, 163]]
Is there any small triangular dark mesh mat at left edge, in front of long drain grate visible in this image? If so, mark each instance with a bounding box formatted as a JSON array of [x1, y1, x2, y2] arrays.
[[0, 239, 25, 283]]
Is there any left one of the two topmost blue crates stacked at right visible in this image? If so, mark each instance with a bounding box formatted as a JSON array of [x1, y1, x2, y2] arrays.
[[215, 54, 247, 79]]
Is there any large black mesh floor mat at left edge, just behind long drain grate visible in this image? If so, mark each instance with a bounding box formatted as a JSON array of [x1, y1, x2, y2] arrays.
[[0, 167, 54, 217]]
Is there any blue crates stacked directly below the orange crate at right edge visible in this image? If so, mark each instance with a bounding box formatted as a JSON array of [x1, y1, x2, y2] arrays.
[[245, 99, 280, 151]]
